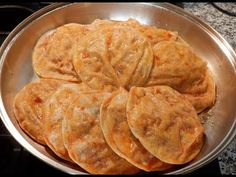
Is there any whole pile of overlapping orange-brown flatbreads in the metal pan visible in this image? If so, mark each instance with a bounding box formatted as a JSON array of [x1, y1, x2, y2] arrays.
[[13, 19, 215, 174]]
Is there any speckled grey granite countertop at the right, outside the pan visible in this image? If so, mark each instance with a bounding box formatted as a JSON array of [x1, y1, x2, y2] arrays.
[[183, 3, 236, 175]]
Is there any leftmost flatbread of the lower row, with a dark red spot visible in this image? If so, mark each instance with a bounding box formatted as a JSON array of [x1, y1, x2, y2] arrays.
[[13, 79, 65, 144]]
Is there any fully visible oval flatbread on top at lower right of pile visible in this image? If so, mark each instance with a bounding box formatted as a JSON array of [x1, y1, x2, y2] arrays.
[[127, 86, 204, 164]]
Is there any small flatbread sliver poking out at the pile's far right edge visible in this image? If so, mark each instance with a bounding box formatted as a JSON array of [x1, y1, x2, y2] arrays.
[[183, 71, 216, 113]]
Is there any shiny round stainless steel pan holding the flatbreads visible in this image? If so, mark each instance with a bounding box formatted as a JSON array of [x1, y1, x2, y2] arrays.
[[0, 3, 236, 174]]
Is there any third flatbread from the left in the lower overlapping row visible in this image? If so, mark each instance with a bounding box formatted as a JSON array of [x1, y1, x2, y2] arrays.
[[62, 92, 139, 174]]
